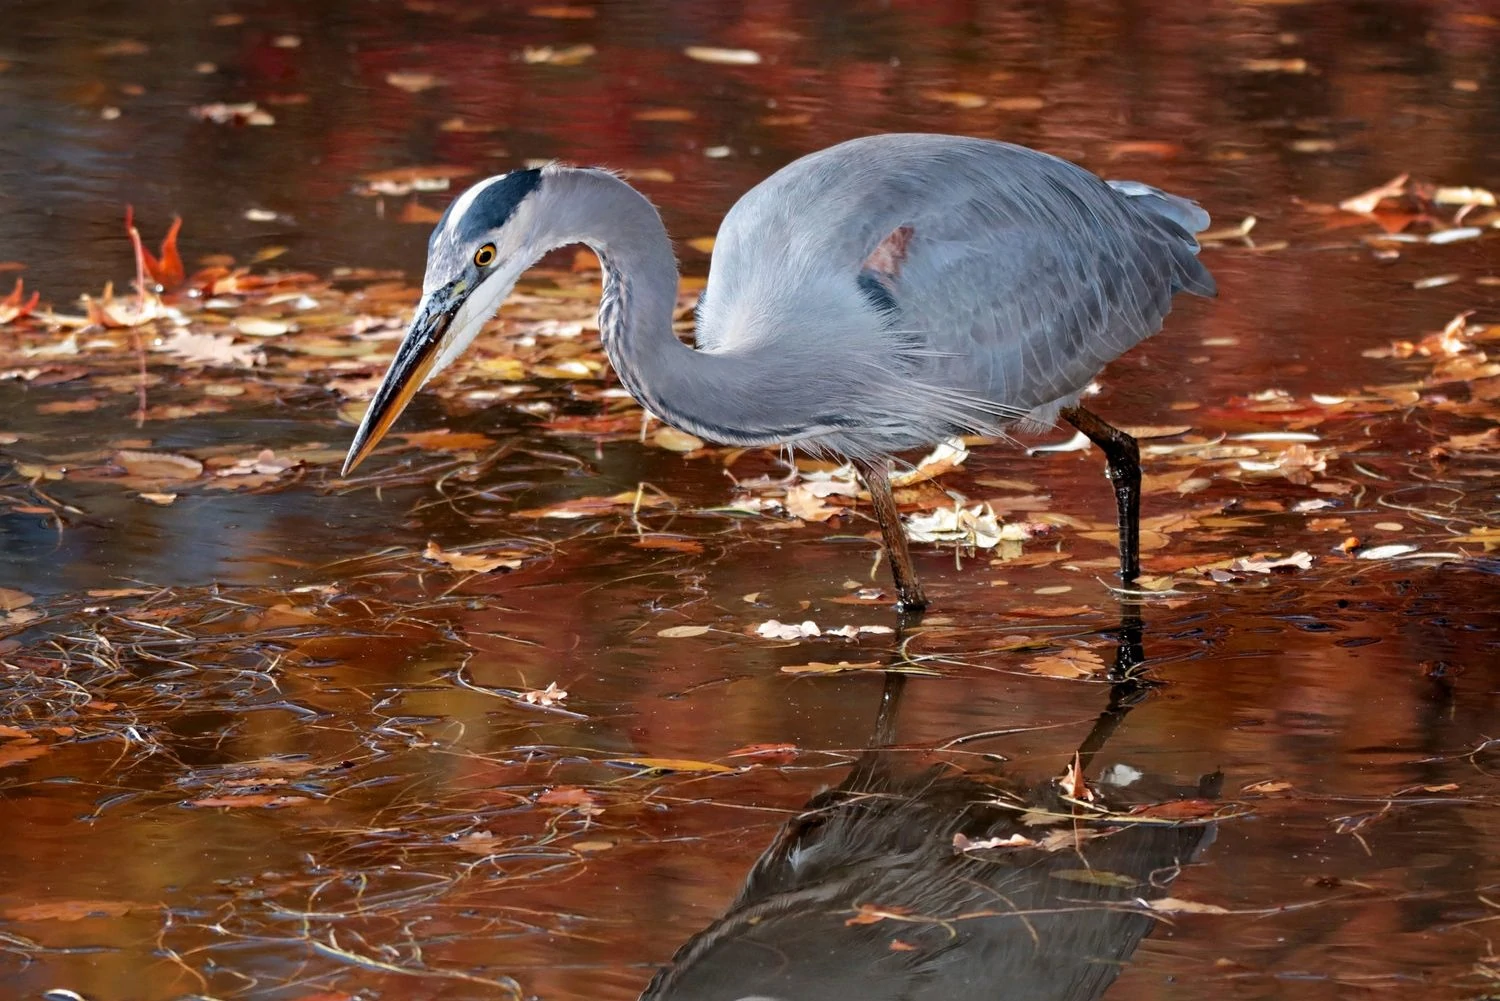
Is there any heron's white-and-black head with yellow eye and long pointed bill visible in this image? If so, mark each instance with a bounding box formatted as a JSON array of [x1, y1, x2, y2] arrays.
[[344, 170, 545, 476]]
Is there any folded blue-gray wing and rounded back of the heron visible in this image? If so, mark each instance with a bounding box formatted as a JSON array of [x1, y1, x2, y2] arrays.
[[701, 134, 1214, 441]]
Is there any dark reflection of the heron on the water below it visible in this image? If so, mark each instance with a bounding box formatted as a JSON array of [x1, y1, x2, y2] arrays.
[[642, 608, 1220, 1001]]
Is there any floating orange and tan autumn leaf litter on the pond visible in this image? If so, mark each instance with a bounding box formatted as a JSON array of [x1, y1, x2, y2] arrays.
[[0, 147, 1500, 989]]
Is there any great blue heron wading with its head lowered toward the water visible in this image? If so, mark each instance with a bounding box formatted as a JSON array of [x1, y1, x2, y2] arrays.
[[344, 134, 1215, 611]]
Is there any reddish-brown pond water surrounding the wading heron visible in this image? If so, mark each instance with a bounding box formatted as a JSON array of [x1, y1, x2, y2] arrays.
[[0, 0, 1500, 1001]]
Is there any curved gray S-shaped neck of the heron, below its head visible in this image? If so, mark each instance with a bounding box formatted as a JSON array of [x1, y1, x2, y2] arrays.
[[539, 168, 840, 446]]
